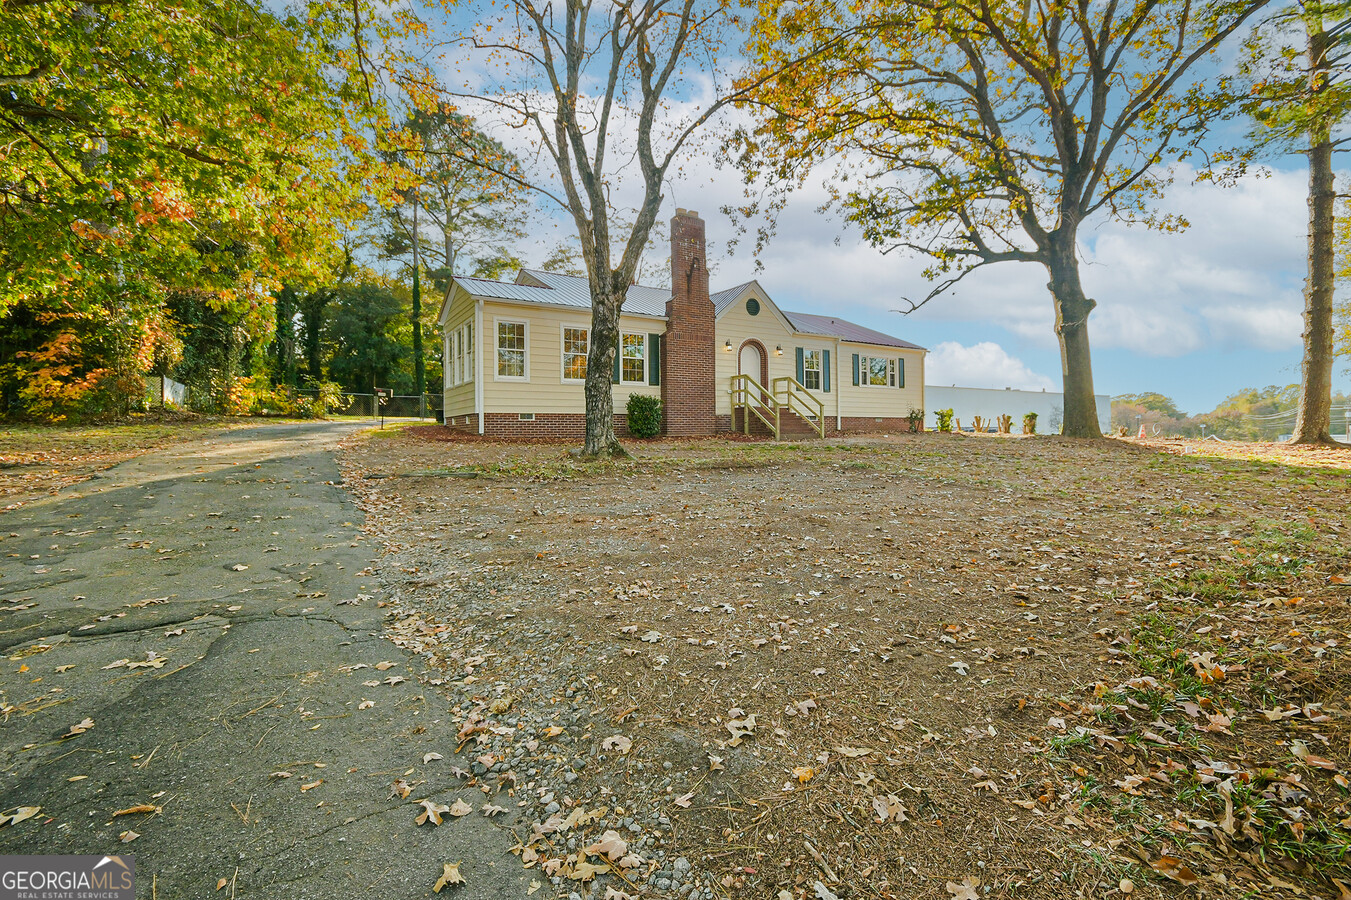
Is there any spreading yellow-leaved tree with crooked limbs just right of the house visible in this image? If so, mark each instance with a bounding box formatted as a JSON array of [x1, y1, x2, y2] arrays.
[[743, 0, 1267, 438]]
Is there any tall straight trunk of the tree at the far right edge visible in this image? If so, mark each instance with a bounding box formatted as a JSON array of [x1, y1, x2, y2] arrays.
[[1290, 22, 1336, 443]]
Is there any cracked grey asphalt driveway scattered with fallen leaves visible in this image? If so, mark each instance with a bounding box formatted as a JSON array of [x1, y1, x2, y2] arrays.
[[0, 423, 537, 900]]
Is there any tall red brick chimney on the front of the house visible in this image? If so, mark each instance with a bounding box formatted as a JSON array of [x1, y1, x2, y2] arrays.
[[662, 208, 717, 435]]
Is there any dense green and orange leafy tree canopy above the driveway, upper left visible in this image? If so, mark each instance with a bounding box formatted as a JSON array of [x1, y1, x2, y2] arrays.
[[0, 0, 389, 416]]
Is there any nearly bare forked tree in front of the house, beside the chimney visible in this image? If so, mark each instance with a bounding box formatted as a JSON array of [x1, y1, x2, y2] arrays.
[[437, 0, 783, 455]]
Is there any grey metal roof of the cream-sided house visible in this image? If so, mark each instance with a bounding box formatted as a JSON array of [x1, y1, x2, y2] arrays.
[[455, 269, 924, 350]]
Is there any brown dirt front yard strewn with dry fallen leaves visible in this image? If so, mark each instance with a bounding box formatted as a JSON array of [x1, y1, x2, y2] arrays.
[[345, 427, 1351, 900]]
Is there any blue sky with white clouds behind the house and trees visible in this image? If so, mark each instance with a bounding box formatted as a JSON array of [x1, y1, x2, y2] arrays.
[[426, 4, 1351, 414]]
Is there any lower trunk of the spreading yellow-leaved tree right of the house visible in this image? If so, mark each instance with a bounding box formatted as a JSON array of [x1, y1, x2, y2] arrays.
[[1046, 235, 1102, 438]]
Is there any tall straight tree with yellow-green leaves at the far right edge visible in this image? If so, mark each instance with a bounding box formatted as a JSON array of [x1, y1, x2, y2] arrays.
[[1244, 0, 1351, 443]]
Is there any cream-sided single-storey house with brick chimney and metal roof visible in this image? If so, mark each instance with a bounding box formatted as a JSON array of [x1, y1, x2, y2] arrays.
[[439, 209, 925, 438]]
